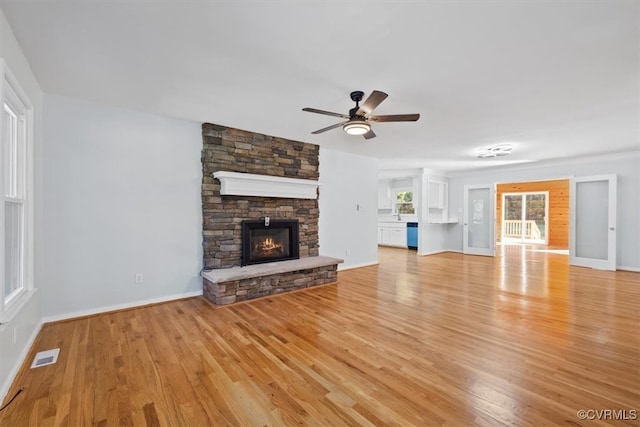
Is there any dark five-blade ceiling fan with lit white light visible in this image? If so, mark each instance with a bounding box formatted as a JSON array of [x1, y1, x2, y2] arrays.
[[302, 90, 420, 139]]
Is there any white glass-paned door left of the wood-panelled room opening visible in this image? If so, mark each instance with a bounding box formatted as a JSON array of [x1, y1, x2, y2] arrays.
[[462, 185, 495, 256]]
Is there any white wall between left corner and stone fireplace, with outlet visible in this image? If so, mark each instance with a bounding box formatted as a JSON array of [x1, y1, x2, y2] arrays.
[[41, 95, 202, 321]]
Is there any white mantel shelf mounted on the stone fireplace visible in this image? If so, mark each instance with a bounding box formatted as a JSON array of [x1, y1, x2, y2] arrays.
[[213, 171, 321, 199]]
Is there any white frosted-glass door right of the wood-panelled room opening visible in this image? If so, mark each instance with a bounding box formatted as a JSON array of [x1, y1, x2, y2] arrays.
[[569, 175, 617, 270]]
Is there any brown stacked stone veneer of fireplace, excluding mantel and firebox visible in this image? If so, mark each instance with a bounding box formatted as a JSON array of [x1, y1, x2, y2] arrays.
[[202, 123, 336, 303]]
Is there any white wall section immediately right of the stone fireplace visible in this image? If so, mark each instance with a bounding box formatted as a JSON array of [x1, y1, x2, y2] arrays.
[[319, 147, 378, 269]]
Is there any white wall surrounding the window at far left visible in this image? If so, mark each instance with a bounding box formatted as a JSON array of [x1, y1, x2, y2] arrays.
[[0, 5, 43, 402]]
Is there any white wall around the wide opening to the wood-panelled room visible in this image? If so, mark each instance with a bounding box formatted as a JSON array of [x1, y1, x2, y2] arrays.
[[445, 151, 640, 270]]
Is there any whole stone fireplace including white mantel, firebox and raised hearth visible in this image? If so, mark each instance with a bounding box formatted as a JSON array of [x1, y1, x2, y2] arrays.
[[202, 123, 342, 305]]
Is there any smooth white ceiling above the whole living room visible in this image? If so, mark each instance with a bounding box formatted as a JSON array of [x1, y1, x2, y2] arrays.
[[0, 0, 640, 171]]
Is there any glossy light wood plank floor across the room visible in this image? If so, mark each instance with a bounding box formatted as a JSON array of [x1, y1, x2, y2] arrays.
[[0, 246, 640, 427]]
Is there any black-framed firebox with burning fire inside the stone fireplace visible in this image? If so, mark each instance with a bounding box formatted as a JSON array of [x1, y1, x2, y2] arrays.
[[242, 217, 300, 266]]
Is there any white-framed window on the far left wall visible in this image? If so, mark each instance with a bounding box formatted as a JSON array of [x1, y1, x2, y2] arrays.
[[0, 60, 33, 323]]
